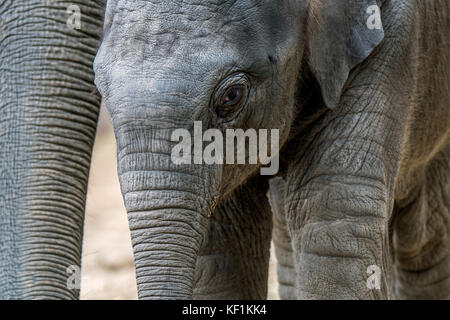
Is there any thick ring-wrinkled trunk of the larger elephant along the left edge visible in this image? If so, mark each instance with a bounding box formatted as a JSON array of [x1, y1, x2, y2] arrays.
[[0, 0, 103, 299]]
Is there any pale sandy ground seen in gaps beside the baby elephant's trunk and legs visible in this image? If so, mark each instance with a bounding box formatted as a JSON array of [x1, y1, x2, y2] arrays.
[[80, 106, 278, 300]]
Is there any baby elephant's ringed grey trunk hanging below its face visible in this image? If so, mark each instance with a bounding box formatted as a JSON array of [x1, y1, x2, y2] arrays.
[[116, 123, 217, 299]]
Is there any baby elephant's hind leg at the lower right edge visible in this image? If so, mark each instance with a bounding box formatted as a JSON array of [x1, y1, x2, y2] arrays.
[[394, 144, 450, 299]]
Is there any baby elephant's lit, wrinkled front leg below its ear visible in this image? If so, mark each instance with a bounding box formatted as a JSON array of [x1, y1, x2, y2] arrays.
[[286, 3, 416, 299]]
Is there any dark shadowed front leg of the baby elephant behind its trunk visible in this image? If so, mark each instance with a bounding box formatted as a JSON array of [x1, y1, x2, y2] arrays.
[[194, 176, 272, 299]]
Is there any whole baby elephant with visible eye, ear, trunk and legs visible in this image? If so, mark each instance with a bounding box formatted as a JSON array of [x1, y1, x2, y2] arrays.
[[94, 0, 450, 299]]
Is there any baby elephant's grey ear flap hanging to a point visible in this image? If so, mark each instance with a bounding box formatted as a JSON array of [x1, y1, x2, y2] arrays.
[[307, 0, 384, 109]]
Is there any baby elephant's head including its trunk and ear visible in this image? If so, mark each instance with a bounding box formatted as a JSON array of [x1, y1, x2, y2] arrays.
[[94, 0, 384, 299]]
